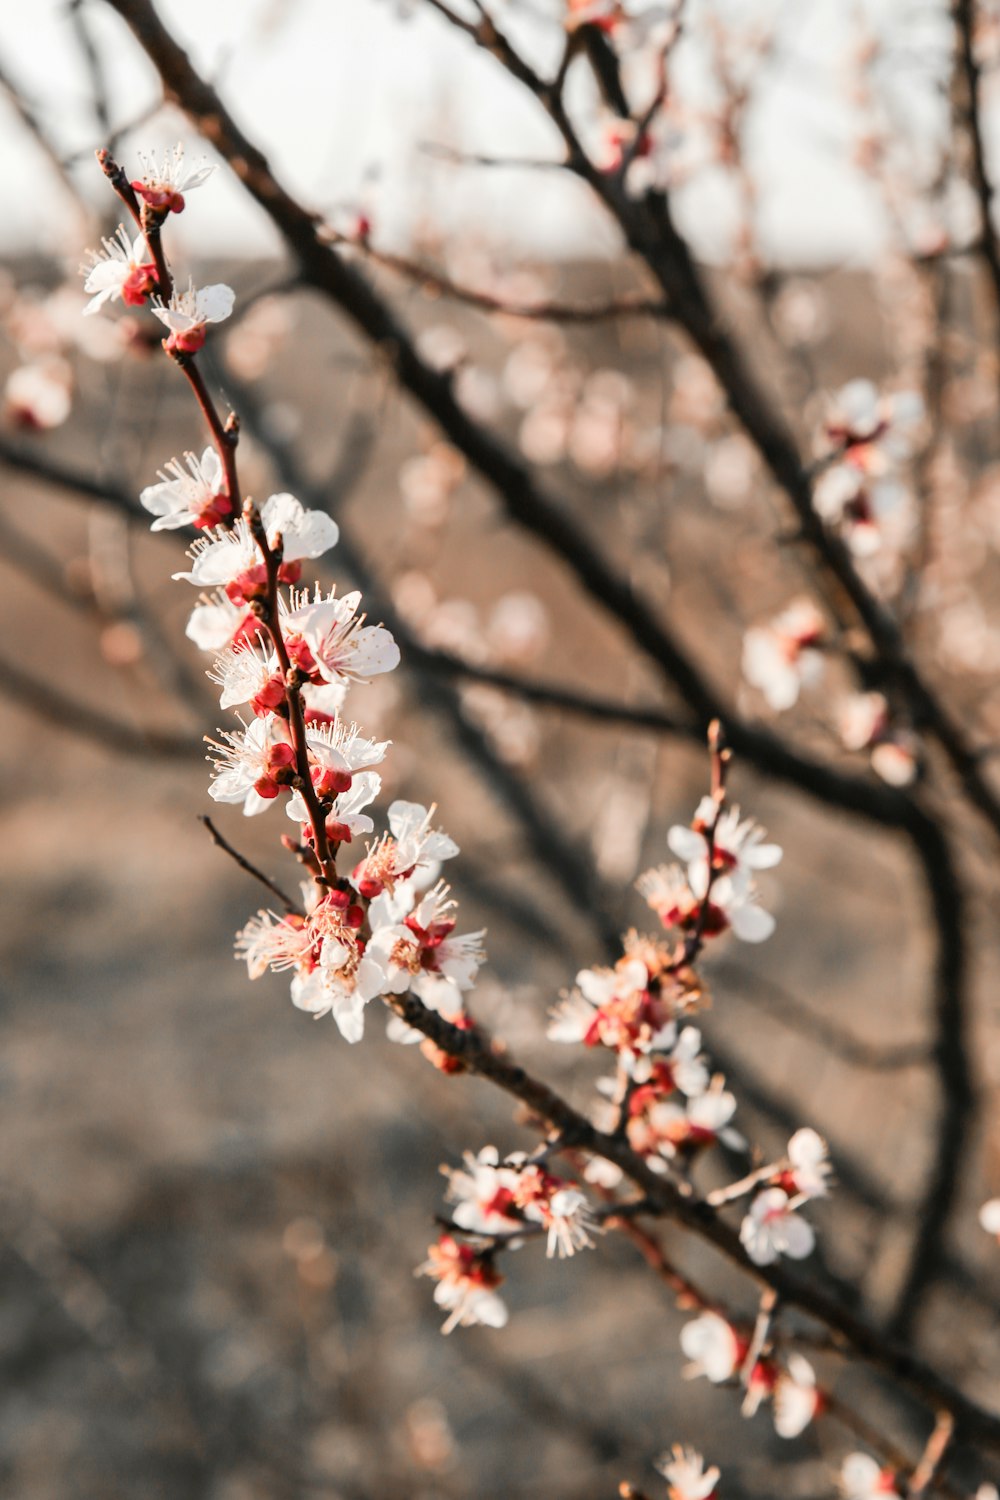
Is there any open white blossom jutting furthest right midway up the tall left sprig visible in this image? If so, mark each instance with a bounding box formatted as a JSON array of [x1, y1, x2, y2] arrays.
[[283, 591, 399, 683]]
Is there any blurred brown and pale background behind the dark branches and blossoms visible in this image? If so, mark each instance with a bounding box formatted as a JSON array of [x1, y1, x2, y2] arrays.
[[0, 0, 1000, 1500]]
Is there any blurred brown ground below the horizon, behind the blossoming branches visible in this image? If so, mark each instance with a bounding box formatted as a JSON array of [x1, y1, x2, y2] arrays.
[[0, 258, 1000, 1500]]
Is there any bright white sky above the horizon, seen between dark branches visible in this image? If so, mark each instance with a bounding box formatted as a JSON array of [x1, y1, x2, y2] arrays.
[[0, 0, 948, 261]]
